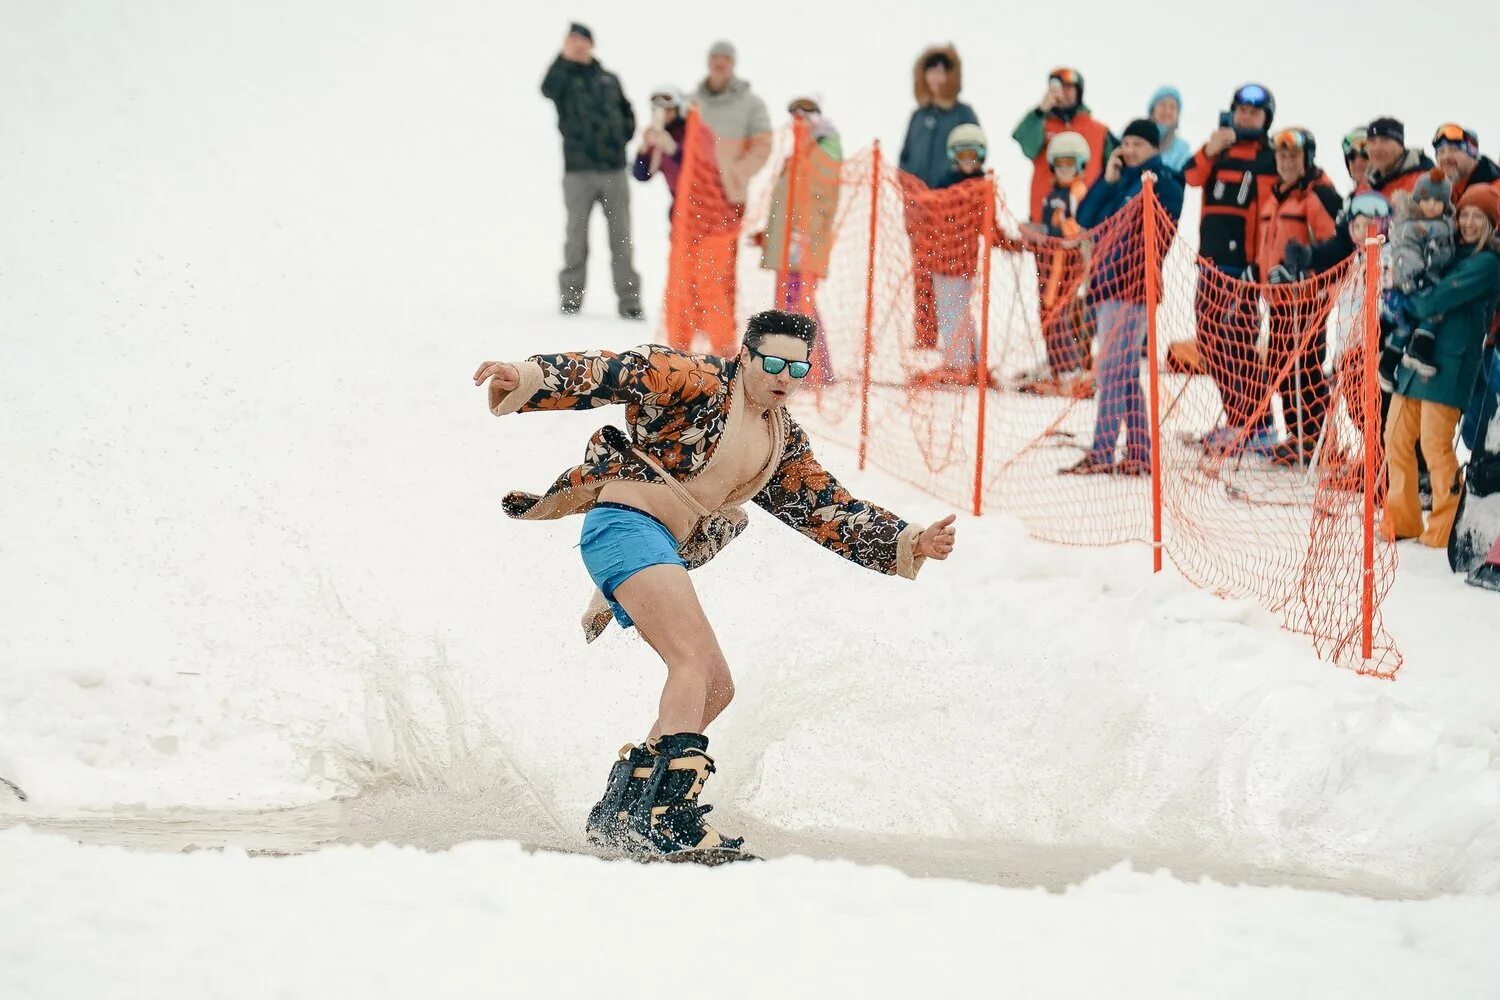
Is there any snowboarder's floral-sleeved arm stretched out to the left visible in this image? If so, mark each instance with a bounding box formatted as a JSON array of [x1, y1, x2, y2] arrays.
[[474, 351, 648, 417]]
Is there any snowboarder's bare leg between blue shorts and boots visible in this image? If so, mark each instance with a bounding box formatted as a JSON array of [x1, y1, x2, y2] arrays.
[[615, 565, 735, 738]]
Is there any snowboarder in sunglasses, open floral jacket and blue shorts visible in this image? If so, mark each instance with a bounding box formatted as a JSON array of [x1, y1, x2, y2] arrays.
[[474, 310, 954, 859]]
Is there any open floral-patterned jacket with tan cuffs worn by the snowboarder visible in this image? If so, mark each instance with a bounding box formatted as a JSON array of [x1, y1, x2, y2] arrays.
[[491, 345, 924, 640]]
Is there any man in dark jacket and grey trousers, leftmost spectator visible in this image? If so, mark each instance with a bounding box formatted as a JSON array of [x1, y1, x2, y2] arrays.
[[542, 24, 644, 319]]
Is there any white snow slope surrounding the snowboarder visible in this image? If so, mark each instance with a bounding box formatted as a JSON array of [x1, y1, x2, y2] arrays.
[[0, 3, 1500, 997]]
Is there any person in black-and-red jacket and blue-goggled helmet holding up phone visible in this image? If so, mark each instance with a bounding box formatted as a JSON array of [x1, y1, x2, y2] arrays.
[[1182, 84, 1277, 454]]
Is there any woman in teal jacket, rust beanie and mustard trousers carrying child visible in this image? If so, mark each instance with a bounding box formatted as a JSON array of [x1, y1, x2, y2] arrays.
[[1382, 186, 1500, 549]]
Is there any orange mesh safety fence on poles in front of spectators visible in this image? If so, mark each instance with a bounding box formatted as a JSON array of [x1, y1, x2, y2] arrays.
[[665, 118, 1401, 678]]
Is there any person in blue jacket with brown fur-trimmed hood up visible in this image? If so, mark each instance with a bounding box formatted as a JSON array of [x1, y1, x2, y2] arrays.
[[897, 45, 980, 349]]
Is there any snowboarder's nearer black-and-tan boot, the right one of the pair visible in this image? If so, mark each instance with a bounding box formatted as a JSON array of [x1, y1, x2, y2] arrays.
[[630, 733, 746, 855]]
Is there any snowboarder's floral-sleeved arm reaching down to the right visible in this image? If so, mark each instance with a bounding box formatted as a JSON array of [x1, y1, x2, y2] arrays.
[[755, 423, 954, 579]]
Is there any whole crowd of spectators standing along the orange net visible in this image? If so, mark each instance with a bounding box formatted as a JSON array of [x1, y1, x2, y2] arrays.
[[542, 24, 1500, 546]]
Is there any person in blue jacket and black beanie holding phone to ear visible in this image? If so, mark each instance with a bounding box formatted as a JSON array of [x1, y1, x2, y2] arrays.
[[1059, 118, 1182, 475]]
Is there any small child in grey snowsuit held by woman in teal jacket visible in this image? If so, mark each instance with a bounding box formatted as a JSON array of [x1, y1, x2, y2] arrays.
[[1380, 169, 1455, 391]]
